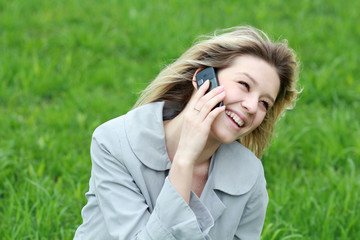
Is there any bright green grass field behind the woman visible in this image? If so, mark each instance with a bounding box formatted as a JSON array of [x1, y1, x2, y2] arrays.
[[0, 0, 360, 240]]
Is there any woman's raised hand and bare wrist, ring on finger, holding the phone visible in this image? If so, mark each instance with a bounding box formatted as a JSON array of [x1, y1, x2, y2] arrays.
[[169, 81, 225, 203]]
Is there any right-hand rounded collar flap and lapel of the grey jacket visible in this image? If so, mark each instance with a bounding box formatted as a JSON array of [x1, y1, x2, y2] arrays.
[[200, 142, 261, 221]]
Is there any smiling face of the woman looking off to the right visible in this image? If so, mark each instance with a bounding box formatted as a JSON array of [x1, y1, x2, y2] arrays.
[[207, 55, 280, 143]]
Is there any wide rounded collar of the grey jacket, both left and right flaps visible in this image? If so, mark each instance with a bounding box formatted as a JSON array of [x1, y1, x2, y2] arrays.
[[125, 102, 262, 195]]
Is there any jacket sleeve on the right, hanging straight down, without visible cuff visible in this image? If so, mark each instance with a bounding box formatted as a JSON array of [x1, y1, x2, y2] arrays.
[[234, 162, 269, 240]]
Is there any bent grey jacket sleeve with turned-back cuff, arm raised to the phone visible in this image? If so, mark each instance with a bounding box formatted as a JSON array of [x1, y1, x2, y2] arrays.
[[91, 124, 213, 240]]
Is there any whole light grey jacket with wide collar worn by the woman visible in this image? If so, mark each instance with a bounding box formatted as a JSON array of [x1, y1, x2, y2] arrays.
[[75, 102, 268, 240]]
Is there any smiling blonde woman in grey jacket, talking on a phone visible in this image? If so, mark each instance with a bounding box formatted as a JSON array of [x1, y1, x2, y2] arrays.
[[75, 27, 298, 240]]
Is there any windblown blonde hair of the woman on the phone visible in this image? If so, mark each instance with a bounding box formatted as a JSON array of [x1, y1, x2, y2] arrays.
[[134, 26, 299, 157]]
